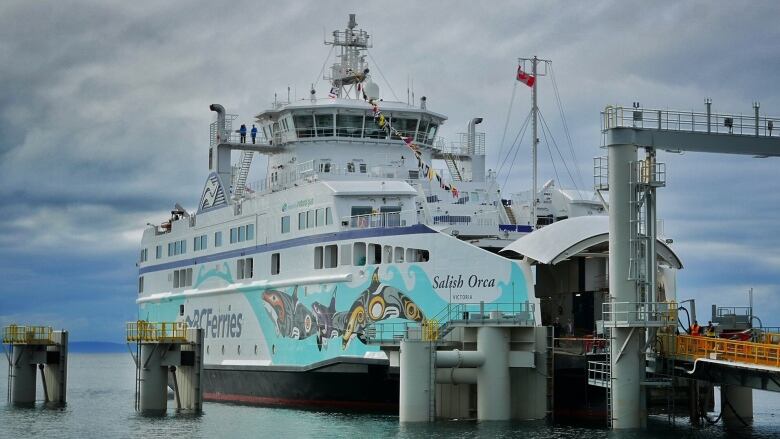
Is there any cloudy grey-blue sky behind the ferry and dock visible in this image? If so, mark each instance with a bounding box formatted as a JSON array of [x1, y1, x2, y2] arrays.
[[0, 0, 780, 341]]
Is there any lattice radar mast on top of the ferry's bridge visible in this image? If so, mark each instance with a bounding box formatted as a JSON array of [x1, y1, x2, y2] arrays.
[[324, 14, 371, 98]]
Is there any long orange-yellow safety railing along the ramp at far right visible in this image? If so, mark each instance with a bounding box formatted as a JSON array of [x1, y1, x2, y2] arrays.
[[663, 335, 780, 367]]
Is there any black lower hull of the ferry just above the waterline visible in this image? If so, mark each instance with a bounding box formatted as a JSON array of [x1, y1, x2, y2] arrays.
[[203, 359, 399, 413]]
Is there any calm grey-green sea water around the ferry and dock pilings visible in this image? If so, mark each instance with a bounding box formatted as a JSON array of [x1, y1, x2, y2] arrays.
[[0, 354, 780, 439]]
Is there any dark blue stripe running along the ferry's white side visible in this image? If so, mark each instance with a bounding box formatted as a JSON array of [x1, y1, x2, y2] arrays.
[[138, 224, 438, 275]]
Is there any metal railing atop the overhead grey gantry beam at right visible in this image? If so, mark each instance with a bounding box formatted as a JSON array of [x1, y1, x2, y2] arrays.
[[601, 106, 780, 137]]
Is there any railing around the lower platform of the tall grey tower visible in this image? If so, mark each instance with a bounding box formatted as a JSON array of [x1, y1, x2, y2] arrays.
[[601, 302, 677, 326]]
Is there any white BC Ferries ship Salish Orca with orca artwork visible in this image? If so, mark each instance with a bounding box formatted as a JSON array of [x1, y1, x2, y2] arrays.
[[136, 14, 606, 411]]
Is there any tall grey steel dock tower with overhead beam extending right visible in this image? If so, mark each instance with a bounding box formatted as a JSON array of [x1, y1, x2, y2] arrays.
[[596, 99, 780, 429]]
